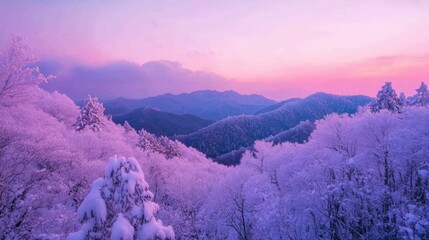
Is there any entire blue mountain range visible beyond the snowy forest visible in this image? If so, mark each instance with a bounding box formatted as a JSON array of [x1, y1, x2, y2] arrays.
[[103, 90, 372, 165]]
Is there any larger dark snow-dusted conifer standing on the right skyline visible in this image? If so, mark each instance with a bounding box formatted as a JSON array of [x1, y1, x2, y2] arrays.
[[370, 82, 401, 112]]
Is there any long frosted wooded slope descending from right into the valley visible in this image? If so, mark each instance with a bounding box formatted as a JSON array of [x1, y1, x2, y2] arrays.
[[176, 93, 371, 158]]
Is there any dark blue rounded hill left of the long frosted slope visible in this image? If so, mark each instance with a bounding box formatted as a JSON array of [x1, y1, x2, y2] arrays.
[[112, 107, 213, 136]]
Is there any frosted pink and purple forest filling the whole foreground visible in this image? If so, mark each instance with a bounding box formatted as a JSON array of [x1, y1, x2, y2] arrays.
[[0, 37, 429, 240]]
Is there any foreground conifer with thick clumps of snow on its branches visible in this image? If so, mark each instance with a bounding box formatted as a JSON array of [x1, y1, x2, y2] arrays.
[[68, 156, 174, 240]]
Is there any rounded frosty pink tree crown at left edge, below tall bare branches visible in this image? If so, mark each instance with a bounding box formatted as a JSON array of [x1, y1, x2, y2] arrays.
[[0, 104, 77, 239]]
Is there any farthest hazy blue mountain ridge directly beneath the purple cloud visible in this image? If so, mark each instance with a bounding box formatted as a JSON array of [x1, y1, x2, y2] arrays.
[[104, 90, 275, 120]]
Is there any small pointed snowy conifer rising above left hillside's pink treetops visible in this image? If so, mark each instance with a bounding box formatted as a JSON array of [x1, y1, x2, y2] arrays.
[[73, 96, 105, 132]]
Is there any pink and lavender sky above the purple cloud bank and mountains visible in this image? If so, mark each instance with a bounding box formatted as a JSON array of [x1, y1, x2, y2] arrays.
[[0, 0, 429, 99]]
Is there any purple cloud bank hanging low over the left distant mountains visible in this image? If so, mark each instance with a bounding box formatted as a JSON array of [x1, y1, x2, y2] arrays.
[[41, 60, 230, 100]]
